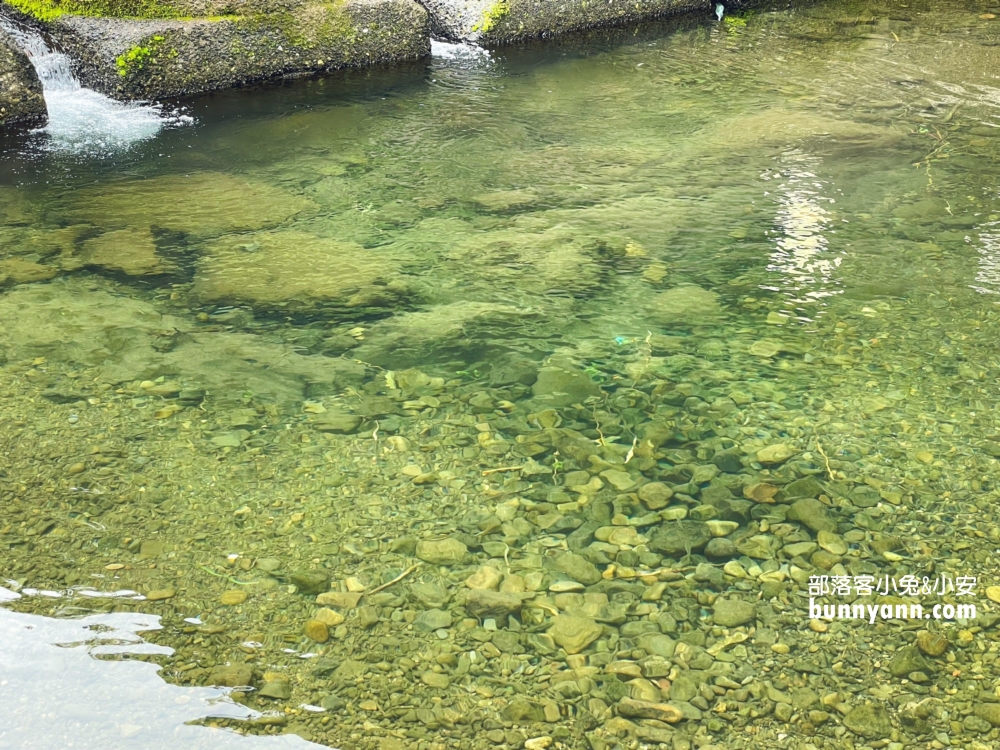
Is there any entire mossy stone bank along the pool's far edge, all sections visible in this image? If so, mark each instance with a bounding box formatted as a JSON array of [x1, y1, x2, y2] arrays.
[[0, 0, 742, 114]]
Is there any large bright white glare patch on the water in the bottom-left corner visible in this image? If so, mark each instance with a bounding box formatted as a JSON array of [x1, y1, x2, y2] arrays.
[[0, 587, 319, 750]]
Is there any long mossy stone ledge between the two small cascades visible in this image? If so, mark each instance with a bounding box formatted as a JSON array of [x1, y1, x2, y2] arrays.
[[0, 0, 430, 99]]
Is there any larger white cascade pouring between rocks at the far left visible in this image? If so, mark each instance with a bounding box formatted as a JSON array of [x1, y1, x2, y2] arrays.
[[0, 16, 193, 153]]
